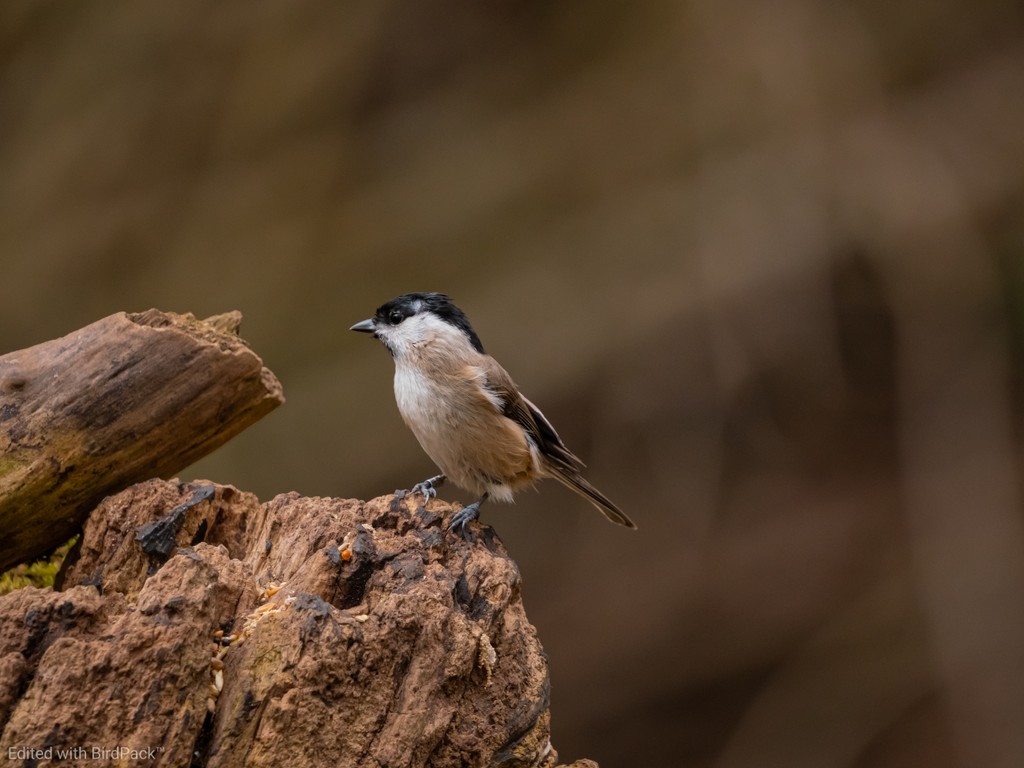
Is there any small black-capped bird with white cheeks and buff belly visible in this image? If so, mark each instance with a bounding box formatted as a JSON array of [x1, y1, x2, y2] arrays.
[[349, 293, 637, 538]]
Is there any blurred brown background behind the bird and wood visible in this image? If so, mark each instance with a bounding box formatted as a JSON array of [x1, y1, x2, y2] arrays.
[[0, 0, 1024, 768]]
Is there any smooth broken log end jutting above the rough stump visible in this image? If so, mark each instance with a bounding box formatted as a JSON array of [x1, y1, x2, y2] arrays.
[[0, 309, 284, 570]]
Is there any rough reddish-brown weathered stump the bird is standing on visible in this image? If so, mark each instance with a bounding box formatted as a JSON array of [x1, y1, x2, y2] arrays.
[[0, 480, 594, 768]]
